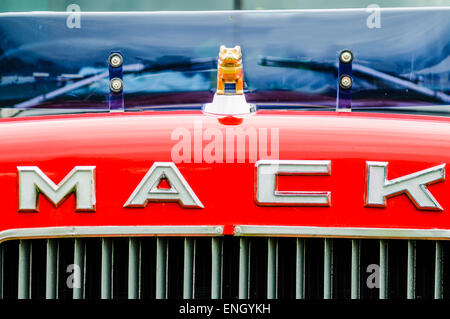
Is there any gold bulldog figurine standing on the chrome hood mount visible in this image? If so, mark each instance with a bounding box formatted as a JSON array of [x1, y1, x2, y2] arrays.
[[216, 45, 244, 95]]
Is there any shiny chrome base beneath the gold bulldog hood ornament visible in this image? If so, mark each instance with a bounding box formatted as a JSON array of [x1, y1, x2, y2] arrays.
[[203, 94, 256, 115]]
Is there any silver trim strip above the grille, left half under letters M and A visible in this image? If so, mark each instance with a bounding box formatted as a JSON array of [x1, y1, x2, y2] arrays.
[[0, 225, 223, 243]]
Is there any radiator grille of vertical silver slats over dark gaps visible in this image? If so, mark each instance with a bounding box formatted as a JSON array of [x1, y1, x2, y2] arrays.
[[0, 236, 450, 299]]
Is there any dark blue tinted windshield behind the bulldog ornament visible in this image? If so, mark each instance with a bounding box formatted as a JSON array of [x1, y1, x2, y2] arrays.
[[0, 8, 450, 109]]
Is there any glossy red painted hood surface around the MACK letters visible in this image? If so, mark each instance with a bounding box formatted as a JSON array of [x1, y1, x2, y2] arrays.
[[0, 111, 450, 238]]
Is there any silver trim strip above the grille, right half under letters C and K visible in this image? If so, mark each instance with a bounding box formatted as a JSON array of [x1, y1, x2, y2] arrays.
[[234, 225, 450, 240]]
